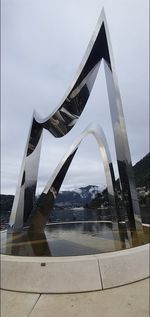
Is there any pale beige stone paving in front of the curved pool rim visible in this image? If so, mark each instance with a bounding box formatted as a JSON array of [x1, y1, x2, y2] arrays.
[[1, 279, 149, 317]]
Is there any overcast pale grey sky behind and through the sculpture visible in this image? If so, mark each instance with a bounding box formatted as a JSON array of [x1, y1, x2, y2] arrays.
[[1, 0, 149, 194]]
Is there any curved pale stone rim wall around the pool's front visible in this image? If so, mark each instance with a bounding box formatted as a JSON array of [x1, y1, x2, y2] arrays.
[[1, 244, 150, 293]]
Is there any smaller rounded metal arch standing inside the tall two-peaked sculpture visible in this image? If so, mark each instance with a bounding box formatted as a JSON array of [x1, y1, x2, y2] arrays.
[[31, 124, 117, 231]]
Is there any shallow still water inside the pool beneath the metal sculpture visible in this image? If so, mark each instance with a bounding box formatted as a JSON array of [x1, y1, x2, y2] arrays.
[[1, 220, 149, 256]]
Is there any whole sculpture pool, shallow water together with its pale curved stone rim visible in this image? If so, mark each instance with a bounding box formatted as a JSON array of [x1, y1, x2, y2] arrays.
[[1, 221, 149, 293]]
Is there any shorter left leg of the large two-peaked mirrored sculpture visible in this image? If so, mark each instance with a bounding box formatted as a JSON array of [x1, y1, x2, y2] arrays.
[[9, 118, 42, 231]]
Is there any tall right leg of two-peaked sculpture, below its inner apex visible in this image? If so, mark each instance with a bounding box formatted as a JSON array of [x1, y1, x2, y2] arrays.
[[104, 63, 143, 237]]
